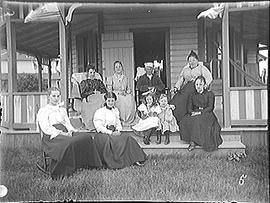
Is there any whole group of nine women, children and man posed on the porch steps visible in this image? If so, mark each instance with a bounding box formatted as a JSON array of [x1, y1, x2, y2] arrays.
[[37, 51, 222, 177]]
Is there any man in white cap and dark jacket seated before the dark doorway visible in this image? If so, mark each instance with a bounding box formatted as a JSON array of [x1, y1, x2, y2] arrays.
[[137, 62, 165, 98]]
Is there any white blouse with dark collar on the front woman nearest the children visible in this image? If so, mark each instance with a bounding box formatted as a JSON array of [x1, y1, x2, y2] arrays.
[[93, 107, 122, 135]]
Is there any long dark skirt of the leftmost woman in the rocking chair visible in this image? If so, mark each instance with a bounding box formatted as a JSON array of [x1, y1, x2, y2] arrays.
[[42, 124, 103, 178]]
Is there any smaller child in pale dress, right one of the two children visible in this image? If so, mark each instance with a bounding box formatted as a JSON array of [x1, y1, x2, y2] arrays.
[[156, 94, 179, 145]]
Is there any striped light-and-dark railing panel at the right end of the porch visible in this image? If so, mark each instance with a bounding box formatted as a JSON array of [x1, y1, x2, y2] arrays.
[[230, 87, 268, 125]]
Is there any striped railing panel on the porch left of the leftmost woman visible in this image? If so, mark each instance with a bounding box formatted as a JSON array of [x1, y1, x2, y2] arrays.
[[14, 92, 47, 127]]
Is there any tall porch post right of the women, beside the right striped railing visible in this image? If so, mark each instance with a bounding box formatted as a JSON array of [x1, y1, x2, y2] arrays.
[[222, 3, 231, 128]]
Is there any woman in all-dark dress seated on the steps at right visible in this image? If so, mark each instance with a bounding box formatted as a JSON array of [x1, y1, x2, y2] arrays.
[[179, 76, 222, 151]]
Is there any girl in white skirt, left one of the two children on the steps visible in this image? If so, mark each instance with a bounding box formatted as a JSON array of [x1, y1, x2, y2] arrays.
[[132, 94, 161, 145]]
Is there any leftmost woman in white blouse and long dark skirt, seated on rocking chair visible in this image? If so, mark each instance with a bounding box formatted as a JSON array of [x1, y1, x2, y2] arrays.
[[37, 87, 102, 178]]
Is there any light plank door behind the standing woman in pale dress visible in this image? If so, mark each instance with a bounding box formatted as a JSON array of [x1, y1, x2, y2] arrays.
[[102, 32, 134, 95]]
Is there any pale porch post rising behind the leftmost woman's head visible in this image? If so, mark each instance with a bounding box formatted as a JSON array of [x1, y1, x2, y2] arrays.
[[58, 7, 68, 109]]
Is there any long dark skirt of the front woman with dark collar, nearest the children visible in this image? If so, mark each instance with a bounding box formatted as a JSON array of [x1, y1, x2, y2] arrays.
[[94, 133, 146, 169]]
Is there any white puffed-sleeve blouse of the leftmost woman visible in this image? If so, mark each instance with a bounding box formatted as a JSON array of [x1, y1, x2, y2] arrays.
[[37, 104, 77, 139]]
